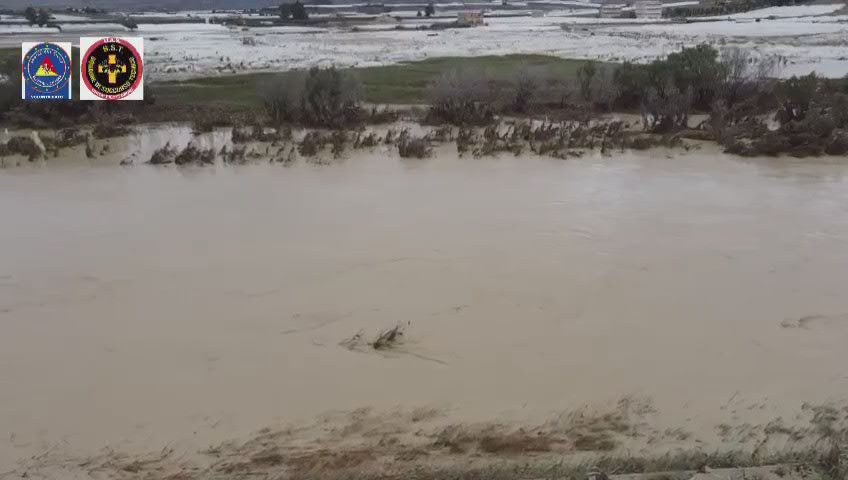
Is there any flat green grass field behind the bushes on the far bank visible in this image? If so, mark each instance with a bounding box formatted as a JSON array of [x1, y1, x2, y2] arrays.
[[153, 55, 583, 106]]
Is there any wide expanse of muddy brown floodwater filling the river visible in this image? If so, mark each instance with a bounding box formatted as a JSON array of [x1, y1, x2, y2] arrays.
[[0, 130, 848, 473]]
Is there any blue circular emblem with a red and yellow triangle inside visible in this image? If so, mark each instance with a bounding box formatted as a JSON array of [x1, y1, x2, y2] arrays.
[[22, 43, 72, 98]]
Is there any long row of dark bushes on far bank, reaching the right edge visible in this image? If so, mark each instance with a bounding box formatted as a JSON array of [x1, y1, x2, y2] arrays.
[[427, 44, 848, 156]]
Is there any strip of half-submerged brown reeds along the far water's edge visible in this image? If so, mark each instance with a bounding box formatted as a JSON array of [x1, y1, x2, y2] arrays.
[[0, 118, 714, 169]]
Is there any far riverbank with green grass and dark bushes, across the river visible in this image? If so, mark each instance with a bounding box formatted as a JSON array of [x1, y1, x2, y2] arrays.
[[9, 44, 848, 157]]
